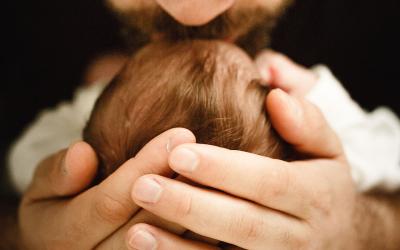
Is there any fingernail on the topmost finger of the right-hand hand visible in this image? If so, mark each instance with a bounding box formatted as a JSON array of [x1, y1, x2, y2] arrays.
[[169, 148, 200, 172]]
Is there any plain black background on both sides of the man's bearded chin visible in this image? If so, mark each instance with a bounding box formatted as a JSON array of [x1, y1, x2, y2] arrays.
[[0, 0, 400, 195]]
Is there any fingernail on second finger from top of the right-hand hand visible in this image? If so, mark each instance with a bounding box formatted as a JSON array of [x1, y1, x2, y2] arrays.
[[132, 178, 162, 203]]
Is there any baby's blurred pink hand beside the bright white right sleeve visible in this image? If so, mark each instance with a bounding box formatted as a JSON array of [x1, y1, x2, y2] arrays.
[[256, 50, 317, 96]]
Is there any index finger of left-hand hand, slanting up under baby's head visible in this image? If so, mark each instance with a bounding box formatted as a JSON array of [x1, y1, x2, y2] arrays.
[[58, 129, 195, 249]]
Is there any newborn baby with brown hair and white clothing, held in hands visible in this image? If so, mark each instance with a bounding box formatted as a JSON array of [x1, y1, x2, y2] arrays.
[[8, 38, 400, 193]]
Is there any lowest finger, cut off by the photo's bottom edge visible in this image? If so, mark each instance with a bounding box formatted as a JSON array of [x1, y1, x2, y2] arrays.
[[126, 224, 219, 250]]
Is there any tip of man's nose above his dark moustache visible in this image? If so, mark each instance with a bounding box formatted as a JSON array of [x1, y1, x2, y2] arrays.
[[156, 0, 236, 26]]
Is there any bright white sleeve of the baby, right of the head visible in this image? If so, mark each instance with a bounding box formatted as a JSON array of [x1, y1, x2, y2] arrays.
[[307, 65, 400, 191]]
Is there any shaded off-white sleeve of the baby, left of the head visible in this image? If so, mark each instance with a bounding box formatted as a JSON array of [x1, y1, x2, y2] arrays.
[[7, 83, 105, 193]]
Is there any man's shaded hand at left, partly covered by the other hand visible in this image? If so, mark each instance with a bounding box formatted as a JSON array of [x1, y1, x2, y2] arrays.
[[19, 129, 219, 249]]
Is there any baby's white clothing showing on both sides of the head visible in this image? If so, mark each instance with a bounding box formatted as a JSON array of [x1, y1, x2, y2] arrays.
[[9, 66, 400, 192]]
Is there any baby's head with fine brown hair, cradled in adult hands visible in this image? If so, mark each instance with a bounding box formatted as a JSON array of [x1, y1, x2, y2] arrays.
[[83, 40, 286, 179]]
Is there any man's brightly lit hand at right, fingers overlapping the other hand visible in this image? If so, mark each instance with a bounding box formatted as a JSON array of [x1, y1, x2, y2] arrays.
[[127, 90, 400, 249]]
